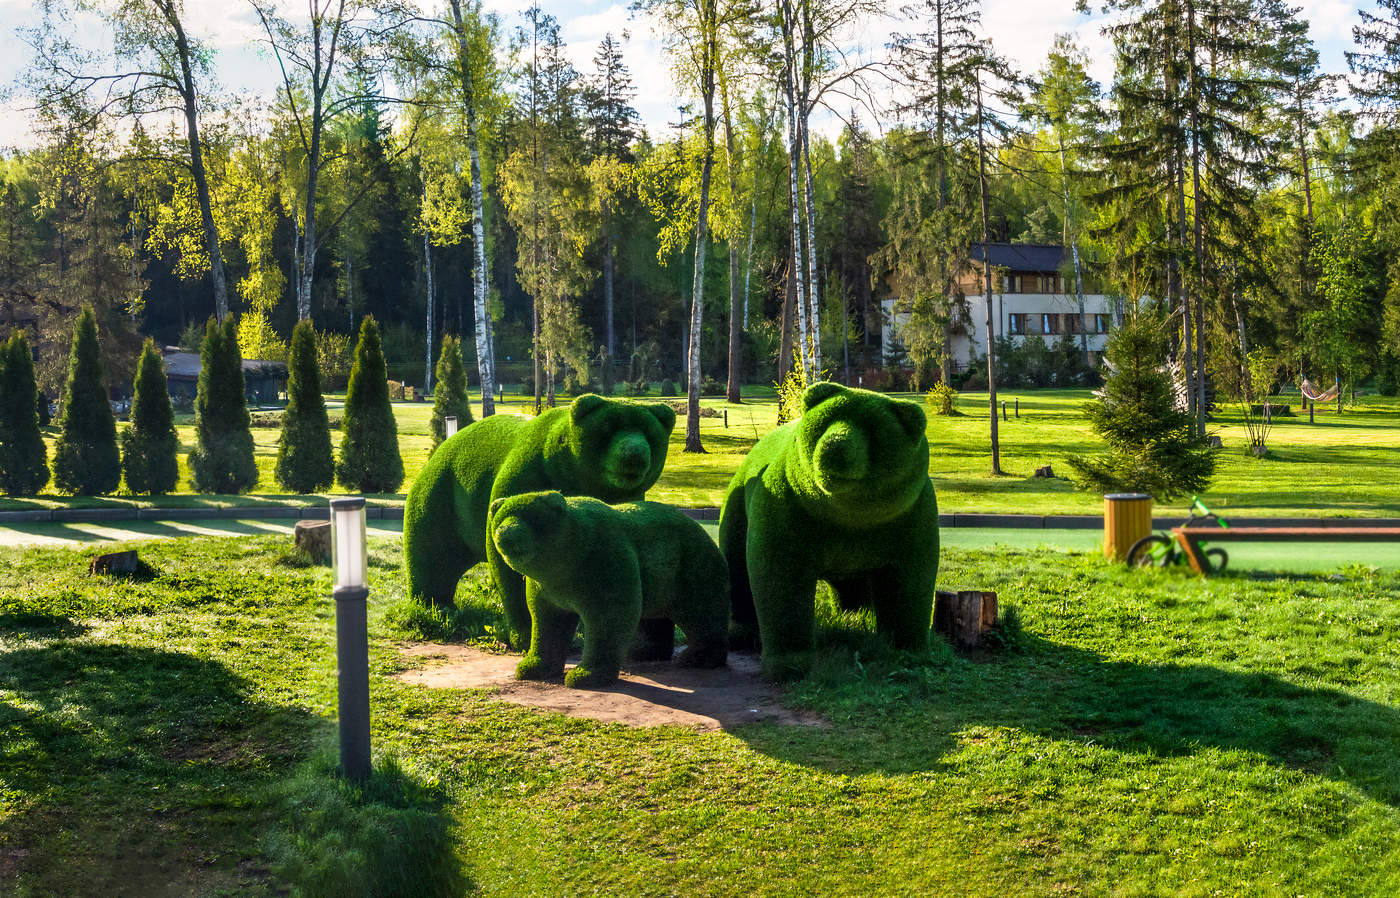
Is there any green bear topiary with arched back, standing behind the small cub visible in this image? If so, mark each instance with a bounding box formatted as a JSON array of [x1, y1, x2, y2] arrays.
[[403, 394, 676, 647]]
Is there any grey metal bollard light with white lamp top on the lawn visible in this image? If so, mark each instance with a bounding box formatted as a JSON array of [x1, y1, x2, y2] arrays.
[[330, 496, 370, 780]]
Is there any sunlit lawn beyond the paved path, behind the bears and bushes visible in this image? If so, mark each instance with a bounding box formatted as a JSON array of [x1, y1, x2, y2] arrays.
[[8, 388, 1400, 517]]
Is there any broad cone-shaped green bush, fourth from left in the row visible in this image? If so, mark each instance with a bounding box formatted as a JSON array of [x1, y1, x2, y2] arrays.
[[189, 317, 258, 493]]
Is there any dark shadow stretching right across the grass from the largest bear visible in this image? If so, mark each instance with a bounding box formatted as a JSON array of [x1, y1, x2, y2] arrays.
[[739, 635, 1400, 807]]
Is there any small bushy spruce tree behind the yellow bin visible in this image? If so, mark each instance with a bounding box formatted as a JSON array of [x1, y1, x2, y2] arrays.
[[1067, 310, 1215, 499]]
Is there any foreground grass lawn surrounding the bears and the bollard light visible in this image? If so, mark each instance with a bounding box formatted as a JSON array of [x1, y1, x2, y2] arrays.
[[0, 532, 1400, 897]]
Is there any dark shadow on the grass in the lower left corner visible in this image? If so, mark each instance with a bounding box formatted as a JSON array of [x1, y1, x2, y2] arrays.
[[0, 641, 466, 897]]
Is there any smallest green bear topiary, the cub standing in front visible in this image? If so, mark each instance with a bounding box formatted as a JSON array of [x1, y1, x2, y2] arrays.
[[490, 492, 729, 686]]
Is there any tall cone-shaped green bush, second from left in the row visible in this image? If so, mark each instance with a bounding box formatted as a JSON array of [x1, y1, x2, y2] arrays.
[[51, 305, 122, 496]]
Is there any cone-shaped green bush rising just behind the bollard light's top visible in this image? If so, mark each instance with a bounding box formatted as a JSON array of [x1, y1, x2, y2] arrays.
[[336, 315, 403, 493]]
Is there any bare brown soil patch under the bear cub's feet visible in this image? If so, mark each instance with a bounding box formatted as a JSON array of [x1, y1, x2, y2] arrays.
[[396, 643, 829, 730]]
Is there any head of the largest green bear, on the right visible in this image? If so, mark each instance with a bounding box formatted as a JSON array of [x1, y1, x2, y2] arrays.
[[794, 382, 928, 524]]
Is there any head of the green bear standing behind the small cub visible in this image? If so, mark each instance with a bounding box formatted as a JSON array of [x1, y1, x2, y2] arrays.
[[568, 394, 676, 502]]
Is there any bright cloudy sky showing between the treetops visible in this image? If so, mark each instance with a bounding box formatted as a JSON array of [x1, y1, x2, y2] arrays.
[[0, 0, 1372, 147]]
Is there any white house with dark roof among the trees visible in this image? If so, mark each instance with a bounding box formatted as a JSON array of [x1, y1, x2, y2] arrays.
[[881, 244, 1121, 367]]
